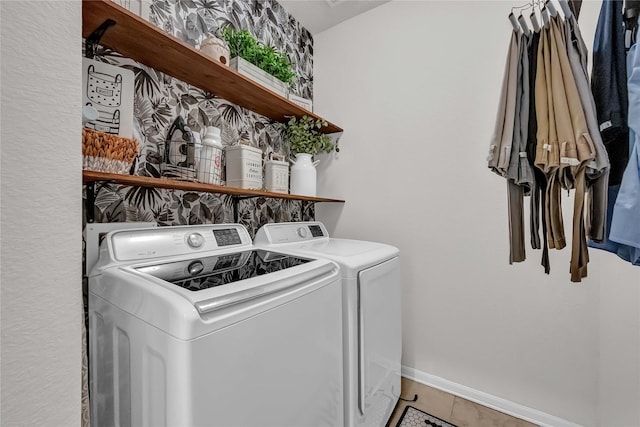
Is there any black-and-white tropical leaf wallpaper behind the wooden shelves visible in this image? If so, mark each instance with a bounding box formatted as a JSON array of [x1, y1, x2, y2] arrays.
[[84, 0, 315, 236]]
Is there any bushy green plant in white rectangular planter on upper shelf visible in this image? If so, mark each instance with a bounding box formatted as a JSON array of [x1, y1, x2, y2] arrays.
[[222, 26, 296, 97]]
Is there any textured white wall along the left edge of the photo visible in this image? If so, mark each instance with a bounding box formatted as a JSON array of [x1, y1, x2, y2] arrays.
[[0, 1, 82, 427]]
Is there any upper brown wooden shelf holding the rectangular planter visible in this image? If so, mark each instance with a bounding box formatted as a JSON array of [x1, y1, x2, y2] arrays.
[[82, 0, 342, 133]]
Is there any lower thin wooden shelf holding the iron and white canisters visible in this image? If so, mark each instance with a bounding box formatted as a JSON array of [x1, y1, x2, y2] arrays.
[[82, 170, 344, 203]]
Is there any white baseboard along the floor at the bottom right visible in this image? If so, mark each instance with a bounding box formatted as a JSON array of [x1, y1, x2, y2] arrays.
[[402, 365, 584, 427]]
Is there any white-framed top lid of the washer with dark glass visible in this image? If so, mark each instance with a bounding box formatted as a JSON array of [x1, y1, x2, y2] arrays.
[[89, 251, 340, 340]]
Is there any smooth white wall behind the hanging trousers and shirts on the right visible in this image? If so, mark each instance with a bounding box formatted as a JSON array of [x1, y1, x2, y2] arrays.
[[314, 1, 640, 427]]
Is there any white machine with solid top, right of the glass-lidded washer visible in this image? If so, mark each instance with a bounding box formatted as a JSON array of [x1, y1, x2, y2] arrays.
[[254, 222, 402, 427]]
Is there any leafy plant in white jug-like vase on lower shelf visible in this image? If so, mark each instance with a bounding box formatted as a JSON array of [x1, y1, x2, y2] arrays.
[[280, 115, 340, 197]]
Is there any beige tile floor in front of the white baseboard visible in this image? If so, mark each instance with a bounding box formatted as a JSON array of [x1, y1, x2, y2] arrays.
[[387, 377, 536, 427]]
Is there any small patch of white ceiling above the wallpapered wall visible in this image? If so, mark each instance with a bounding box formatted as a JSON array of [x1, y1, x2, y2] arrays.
[[278, 0, 389, 35]]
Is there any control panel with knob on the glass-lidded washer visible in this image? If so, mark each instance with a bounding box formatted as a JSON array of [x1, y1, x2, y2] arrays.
[[107, 224, 252, 261]]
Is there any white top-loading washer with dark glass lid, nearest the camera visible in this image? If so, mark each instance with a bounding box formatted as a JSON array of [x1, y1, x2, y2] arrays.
[[89, 224, 344, 427]]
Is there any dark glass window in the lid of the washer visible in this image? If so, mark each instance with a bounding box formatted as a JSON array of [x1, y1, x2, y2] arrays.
[[135, 250, 312, 291]]
